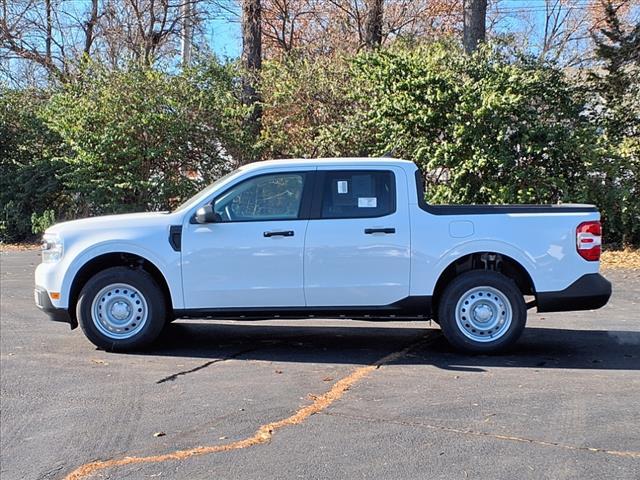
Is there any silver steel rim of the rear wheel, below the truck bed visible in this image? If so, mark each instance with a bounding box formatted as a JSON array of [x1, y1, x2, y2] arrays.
[[455, 286, 513, 343]]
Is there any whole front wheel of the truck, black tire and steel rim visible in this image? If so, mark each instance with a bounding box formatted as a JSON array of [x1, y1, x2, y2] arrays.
[[76, 267, 167, 351]]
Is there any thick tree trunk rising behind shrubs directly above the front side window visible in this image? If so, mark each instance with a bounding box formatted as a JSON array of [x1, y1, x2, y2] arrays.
[[242, 0, 262, 163]]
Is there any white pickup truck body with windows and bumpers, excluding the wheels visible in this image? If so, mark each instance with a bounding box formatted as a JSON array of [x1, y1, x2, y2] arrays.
[[35, 158, 611, 350]]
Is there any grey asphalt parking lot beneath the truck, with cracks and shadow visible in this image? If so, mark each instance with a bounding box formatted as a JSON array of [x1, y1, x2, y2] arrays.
[[0, 251, 640, 480]]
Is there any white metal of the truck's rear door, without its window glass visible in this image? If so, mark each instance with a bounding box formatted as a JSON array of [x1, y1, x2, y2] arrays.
[[304, 165, 411, 307]]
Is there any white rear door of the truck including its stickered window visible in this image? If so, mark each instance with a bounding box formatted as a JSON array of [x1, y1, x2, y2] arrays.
[[304, 166, 411, 307]]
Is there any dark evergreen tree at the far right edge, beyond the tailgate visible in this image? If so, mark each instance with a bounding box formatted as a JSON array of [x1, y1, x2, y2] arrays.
[[585, 8, 640, 245]]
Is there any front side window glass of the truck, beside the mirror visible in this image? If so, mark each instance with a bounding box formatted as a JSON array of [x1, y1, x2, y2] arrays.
[[213, 173, 304, 222]]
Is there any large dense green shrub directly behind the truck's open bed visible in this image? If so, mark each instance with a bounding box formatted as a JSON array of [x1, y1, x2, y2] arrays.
[[340, 44, 596, 203]]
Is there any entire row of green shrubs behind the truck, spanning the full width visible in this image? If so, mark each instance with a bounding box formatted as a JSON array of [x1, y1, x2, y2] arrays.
[[0, 43, 640, 245]]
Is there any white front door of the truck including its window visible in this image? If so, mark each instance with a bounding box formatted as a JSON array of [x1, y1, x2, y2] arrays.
[[182, 168, 315, 310]]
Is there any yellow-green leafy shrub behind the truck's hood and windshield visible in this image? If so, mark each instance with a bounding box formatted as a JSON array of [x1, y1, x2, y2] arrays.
[[45, 62, 246, 215]]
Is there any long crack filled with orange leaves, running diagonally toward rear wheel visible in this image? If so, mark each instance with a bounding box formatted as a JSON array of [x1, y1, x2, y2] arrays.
[[65, 332, 440, 480]]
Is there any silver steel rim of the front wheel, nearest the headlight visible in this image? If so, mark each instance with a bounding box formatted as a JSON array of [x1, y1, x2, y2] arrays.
[[91, 283, 149, 340]]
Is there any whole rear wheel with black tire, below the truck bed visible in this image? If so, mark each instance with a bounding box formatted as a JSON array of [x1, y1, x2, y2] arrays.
[[438, 270, 527, 353]]
